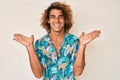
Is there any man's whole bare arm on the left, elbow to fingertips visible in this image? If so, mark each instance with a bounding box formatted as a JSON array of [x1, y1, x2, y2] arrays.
[[13, 34, 43, 78]]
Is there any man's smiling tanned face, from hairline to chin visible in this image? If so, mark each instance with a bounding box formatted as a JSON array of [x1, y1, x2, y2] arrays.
[[48, 9, 65, 32]]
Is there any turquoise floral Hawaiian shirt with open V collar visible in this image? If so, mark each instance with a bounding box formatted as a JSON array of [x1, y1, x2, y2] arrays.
[[35, 33, 79, 80]]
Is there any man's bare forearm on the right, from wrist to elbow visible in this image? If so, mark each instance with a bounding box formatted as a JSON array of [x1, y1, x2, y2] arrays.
[[74, 45, 86, 76]]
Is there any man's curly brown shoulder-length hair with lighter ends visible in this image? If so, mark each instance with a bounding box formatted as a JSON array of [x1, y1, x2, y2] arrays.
[[41, 2, 73, 33]]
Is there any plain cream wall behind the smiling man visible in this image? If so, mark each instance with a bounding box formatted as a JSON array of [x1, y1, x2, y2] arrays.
[[0, 0, 120, 80]]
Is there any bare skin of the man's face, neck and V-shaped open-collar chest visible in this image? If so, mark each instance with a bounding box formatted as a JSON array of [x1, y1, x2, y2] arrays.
[[48, 9, 65, 55]]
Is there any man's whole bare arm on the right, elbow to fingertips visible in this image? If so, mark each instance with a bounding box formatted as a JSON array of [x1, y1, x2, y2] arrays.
[[74, 30, 100, 76]]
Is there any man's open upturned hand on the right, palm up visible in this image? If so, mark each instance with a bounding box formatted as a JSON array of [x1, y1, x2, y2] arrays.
[[80, 30, 100, 46]]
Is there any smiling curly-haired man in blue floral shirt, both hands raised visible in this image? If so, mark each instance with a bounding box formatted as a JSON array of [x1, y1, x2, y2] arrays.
[[14, 2, 100, 80]]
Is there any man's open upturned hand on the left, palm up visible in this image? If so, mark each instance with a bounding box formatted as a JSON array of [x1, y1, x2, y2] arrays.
[[13, 34, 34, 47]]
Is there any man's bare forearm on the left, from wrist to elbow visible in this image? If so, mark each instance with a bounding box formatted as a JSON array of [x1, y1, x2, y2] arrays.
[[26, 45, 43, 78]]
